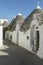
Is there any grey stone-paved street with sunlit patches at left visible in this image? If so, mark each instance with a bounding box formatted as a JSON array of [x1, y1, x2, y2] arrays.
[[0, 40, 43, 65]]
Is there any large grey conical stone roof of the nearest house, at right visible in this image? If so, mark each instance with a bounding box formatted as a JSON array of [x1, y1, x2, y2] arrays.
[[20, 7, 43, 31]]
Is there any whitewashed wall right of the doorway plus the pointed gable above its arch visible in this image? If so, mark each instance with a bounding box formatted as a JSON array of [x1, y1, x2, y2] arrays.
[[30, 16, 43, 58]]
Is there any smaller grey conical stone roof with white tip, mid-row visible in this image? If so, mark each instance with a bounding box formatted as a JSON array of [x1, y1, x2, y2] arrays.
[[9, 13, 24, 30]]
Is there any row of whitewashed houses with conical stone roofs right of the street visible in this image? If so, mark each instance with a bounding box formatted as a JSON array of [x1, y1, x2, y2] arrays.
[[5, 2, 43, 58]]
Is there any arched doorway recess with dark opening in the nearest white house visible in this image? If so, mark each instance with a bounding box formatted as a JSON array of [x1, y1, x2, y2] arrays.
[[30, 25, 39, 53]]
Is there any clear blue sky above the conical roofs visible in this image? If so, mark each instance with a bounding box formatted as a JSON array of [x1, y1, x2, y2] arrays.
[[0, 0, 43, 22]]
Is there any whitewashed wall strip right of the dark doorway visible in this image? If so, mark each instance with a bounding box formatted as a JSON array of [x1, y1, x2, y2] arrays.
[[37, 24, 43, 58]]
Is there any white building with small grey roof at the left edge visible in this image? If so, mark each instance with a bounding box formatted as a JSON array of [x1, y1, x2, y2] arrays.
[[0, 19, 8, 48]]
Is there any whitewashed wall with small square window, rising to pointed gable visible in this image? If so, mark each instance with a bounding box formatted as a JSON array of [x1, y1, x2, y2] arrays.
[[19, 16, 39, 51]]
